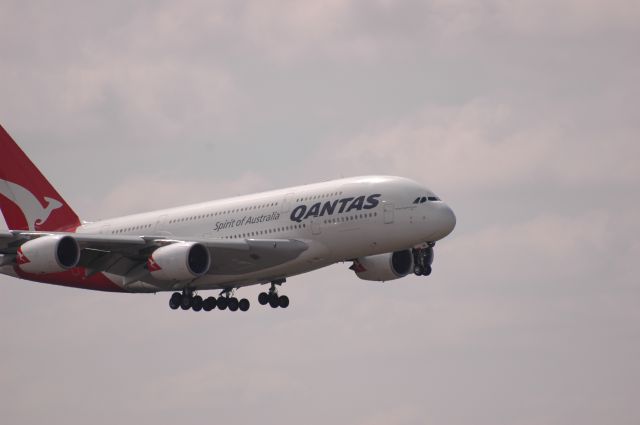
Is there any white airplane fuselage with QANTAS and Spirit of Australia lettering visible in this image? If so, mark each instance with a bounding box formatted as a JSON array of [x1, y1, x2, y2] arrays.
[[77, 176, 455, 290]]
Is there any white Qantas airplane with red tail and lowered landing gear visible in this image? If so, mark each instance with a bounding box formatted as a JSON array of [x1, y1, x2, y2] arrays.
[[0, 126, 456, 311]]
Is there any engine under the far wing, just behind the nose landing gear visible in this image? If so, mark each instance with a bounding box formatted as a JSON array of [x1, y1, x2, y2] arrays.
[[351, 249, 413, 281]]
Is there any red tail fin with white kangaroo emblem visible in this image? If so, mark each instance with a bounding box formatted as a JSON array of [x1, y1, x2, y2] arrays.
[[0, 126, 80, 231]]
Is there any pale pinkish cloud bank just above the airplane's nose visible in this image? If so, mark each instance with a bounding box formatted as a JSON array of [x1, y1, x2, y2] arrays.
[[308, 100, 640, 191]]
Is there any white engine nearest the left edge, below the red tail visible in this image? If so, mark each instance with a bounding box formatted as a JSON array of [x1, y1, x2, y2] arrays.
[[16, 235, 80, 274]]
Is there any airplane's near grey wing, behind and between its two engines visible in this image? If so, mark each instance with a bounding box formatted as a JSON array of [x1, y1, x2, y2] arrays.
[[0, 231, 308, 284]]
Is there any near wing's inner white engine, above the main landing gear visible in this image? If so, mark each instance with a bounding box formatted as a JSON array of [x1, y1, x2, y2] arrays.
[[147, 242, 211, 280]]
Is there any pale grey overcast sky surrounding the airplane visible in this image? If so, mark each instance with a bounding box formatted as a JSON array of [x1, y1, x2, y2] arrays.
[[0, 0, 640, 425]]
